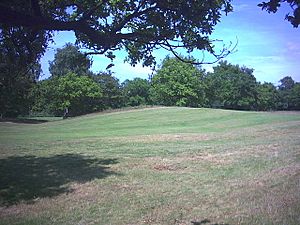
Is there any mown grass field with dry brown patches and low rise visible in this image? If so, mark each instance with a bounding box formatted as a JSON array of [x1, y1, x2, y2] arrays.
[[0, 107, 300, 225]]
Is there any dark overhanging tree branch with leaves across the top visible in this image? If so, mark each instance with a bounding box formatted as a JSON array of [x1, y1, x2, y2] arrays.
[[0, 0, 232, 66]]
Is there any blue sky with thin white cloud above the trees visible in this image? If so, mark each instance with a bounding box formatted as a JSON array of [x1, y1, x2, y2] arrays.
[[41, 0, 300, 85]]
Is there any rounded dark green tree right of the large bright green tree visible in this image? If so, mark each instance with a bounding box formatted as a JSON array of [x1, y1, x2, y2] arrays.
[[205, 61, 257, 110]]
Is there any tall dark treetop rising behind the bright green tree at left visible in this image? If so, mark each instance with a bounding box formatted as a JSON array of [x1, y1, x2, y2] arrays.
[[49, 43, 92, 76]]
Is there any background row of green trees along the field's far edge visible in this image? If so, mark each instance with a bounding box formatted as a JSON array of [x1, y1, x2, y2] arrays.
[[1, 44, 300, 117]]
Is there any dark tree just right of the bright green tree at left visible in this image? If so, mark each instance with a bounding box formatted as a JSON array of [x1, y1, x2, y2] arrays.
[[93, 72, 123, 109]]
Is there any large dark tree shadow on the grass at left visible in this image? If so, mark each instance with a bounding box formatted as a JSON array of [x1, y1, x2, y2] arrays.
[[0, 154, 118, 206]]
